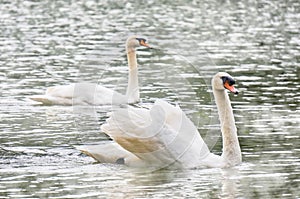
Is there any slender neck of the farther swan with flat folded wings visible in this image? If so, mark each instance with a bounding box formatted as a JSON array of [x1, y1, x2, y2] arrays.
[[126, 47, 140, 103]]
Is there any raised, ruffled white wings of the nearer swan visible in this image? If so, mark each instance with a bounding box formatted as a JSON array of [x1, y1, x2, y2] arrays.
[[101, 100, 209, 167]]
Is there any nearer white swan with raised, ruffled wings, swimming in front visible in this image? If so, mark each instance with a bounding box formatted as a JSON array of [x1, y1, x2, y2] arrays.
[[79, 72, 242, 168]]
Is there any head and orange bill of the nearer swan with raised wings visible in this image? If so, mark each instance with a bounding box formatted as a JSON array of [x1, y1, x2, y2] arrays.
[[212, 72, 239, 94]]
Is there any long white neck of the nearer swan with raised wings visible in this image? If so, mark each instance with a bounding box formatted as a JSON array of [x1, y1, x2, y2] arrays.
[[213, 89, 242, 167]]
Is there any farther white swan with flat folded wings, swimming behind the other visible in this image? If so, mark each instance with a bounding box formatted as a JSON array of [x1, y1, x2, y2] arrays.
[[29, 36, 150, 105]]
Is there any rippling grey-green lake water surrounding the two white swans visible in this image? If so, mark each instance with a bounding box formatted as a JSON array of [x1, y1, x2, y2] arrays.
[[0, 0, 300, 198]]
